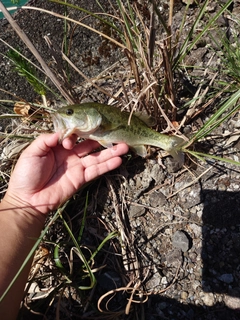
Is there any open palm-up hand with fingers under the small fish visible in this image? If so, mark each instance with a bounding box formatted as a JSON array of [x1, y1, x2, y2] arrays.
[[4, 133, 128, 214]]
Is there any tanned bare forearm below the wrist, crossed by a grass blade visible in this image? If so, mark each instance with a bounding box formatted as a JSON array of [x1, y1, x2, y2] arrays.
[[0, 197, 45, 320]]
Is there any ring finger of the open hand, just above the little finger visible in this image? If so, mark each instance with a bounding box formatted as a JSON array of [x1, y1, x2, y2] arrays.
[[82, 143, 128, 168]]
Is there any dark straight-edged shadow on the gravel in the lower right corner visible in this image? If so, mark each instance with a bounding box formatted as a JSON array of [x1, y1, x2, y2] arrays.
[[146, 190, 240, 320]]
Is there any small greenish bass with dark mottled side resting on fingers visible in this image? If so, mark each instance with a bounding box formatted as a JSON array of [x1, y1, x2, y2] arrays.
[[51, 102, 184, 162]]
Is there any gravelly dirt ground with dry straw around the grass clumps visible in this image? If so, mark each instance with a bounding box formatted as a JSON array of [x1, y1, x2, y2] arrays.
[[0, 0, 240, 320]]
